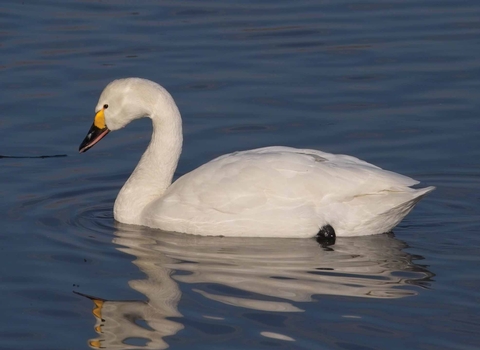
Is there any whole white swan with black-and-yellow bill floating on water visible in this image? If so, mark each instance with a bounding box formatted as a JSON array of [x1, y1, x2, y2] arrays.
[[79, 78, 435, 238]]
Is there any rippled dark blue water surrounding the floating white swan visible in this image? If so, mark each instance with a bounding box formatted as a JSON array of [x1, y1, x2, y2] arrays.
[[0, 0, 480, 350]]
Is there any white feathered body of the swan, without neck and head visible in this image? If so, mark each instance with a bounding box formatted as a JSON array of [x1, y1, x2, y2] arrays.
[[142, 147, 433, 237]]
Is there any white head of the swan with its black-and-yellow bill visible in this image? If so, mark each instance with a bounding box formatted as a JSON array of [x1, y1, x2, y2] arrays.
[[79, 78, 162, 153]]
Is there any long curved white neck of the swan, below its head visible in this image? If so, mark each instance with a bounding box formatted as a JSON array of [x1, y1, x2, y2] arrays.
[[113, 95, 183, 225]]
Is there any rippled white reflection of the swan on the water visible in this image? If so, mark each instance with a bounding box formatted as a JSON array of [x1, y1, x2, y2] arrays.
[[83, 224, 432, 349]]
